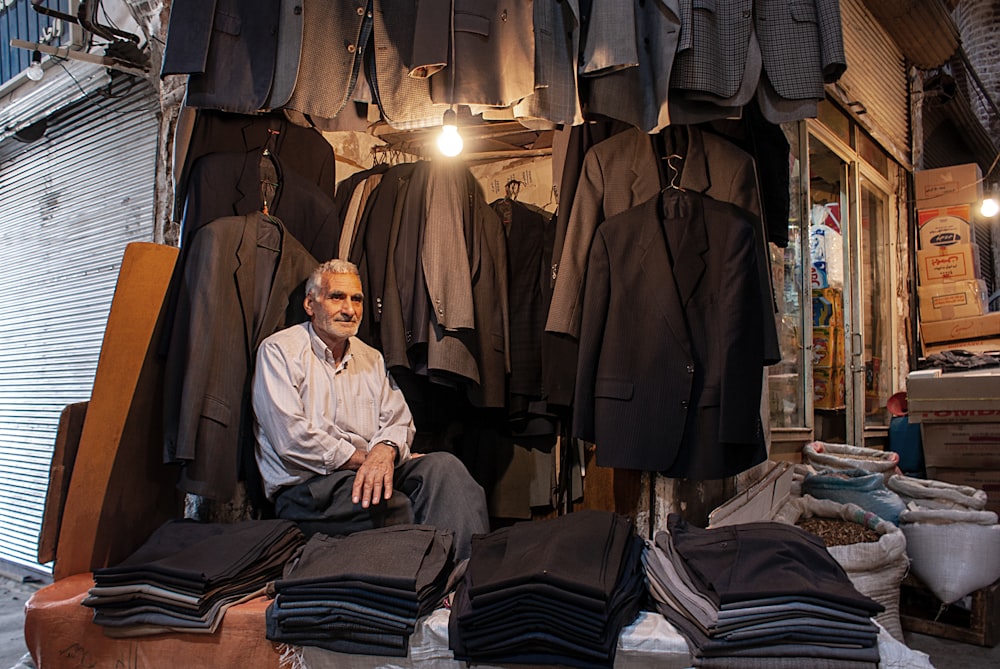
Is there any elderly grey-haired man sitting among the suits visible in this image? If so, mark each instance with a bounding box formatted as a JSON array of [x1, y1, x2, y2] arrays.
[[253, 260, 489, 559]]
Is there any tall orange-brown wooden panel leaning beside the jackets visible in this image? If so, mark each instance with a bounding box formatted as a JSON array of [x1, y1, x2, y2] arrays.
[[53, 242, 183, 579]]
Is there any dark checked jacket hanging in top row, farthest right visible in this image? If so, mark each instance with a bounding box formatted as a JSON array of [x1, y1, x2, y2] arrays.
[[671, 0, 847, 99]]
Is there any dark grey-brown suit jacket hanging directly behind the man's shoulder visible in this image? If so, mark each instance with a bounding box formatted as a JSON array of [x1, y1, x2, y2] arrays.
[[164, 213, 318, 500]]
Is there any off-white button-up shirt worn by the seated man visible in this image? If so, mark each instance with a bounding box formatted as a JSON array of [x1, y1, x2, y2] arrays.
[[253, 323, 415, 499]]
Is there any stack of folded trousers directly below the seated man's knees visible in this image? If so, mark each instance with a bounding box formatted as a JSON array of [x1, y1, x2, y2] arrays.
[[266, 525, 454, 657]]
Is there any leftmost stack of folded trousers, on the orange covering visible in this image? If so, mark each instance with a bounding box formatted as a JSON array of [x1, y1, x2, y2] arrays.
[[83, 519, 305, 637]]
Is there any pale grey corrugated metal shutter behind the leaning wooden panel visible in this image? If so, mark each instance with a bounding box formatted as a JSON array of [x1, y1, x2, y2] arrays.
[[0, 75, 158, 571]]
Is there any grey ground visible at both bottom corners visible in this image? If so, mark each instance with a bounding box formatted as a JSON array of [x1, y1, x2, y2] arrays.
[[0, 576, 1000, 669]]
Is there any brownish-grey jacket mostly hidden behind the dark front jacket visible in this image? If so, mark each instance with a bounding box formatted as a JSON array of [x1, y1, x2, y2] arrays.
[[545, 126, 781, 363]]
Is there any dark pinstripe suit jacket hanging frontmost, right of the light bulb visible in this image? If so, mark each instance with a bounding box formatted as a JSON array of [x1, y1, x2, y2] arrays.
[[573, 190, 766, 479]]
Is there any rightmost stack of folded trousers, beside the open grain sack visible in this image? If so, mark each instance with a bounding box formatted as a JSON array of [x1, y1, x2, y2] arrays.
[[642, 514, 883, 669]]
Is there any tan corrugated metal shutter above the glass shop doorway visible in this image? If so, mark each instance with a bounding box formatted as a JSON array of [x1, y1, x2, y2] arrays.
[[836, 0, 910, 163]]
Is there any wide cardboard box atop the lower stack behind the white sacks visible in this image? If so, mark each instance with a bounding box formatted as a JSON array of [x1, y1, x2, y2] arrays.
[[906, 367, 1000, 423]]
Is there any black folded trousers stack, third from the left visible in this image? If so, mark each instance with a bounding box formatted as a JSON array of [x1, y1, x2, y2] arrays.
[[449, 510, 646, 668]]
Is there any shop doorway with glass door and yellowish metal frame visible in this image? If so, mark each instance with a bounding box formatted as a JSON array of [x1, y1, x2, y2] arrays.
[[807, 117, 905, 446]]
